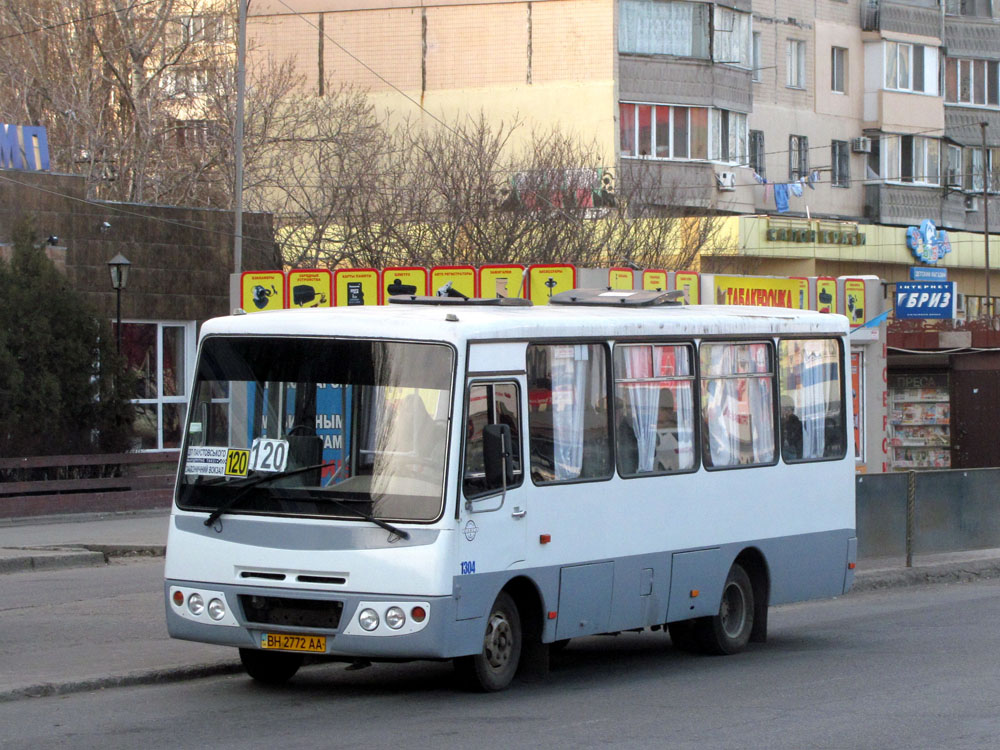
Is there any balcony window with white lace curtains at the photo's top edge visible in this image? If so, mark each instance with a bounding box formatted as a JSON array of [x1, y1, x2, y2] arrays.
[[618, 0, 711, 59]]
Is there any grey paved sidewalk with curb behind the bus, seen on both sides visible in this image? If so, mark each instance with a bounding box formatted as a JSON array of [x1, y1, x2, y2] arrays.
[[0, 511, 1000, 701]]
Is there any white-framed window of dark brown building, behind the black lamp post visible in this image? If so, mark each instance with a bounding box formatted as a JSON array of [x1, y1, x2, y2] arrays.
[[122, 322, 194, 450]]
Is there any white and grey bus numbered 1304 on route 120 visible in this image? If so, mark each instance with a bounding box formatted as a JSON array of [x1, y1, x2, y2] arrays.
[[165, 290, 857, 691]]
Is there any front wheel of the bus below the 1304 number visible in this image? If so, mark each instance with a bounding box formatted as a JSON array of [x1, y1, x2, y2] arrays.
[[455, 591, 522, 693]]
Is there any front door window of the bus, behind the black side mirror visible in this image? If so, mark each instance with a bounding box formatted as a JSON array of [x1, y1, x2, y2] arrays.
[[462, 382, 523, 497]]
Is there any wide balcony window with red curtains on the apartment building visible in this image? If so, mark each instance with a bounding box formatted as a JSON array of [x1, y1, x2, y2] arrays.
[[619, 102, 747, 164]]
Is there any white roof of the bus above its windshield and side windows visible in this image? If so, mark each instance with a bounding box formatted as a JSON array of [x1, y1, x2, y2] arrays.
[[202, 304, 849, 344]]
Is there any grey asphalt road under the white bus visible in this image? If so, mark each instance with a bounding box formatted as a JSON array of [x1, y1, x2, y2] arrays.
[[0, 581, 1000, 750]]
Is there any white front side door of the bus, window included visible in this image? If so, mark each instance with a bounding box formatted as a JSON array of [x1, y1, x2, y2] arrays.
[[459, 378, 528, 575]]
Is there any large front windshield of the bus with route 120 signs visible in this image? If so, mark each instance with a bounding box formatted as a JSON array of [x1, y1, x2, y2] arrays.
[[177, 336, 454, 522]]
